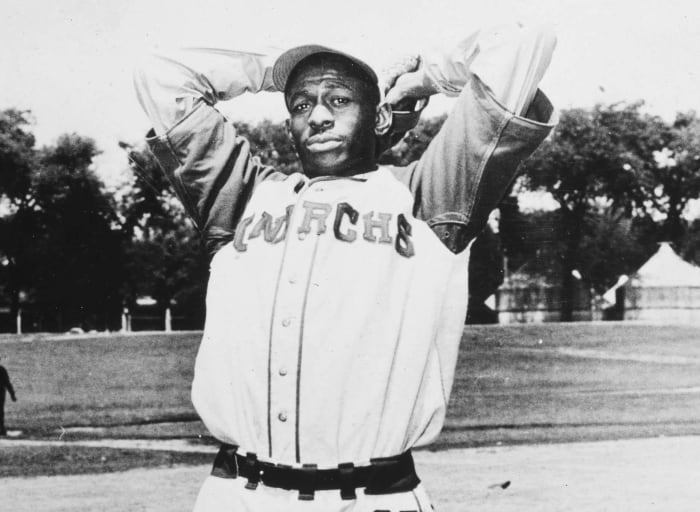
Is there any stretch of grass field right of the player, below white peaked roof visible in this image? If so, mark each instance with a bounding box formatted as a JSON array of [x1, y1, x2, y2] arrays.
[[437, 323, 700, 446]]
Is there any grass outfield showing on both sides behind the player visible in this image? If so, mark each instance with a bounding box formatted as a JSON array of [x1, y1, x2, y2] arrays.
[[0, 323, 700, 474]]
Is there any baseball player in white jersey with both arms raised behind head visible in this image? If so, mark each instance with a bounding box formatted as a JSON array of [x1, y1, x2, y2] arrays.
[[135, 25, 555, 512]]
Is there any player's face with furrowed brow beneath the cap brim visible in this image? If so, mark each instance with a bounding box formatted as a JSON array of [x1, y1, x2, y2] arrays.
[[286, 56, 377, 177]]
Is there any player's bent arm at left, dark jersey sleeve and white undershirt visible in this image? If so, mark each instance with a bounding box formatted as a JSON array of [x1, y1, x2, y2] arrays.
[[134, 49, 284, 254]]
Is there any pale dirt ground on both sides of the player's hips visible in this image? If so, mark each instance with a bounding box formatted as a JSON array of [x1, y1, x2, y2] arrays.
[[0, 436, 700, 512]]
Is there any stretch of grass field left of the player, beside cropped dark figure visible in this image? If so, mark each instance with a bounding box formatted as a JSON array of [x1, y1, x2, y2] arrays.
[[0, 333, 200, 435]]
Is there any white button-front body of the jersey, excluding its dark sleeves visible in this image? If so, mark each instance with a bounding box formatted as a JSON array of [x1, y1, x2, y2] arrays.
[[198, 165, 468, 466]]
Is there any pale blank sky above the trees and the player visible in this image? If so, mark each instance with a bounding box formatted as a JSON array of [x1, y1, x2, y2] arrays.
[[0, 0, 700, 195]]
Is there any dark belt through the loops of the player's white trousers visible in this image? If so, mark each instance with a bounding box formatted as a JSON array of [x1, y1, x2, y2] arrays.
[[211, 444, 420, 500]]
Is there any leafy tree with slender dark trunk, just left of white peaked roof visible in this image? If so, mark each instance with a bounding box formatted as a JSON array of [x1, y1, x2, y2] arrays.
[[523, 103, 672, 320]]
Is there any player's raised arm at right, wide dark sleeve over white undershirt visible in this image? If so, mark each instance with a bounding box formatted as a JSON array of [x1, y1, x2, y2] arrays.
[[397, 27, 556, 252]]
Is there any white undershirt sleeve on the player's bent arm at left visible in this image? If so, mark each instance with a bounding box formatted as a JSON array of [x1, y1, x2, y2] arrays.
[[134, 48, 275, 135]]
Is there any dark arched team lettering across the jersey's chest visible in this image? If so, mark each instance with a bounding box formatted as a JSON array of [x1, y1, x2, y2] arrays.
[[233, 201, 415, 258]]
